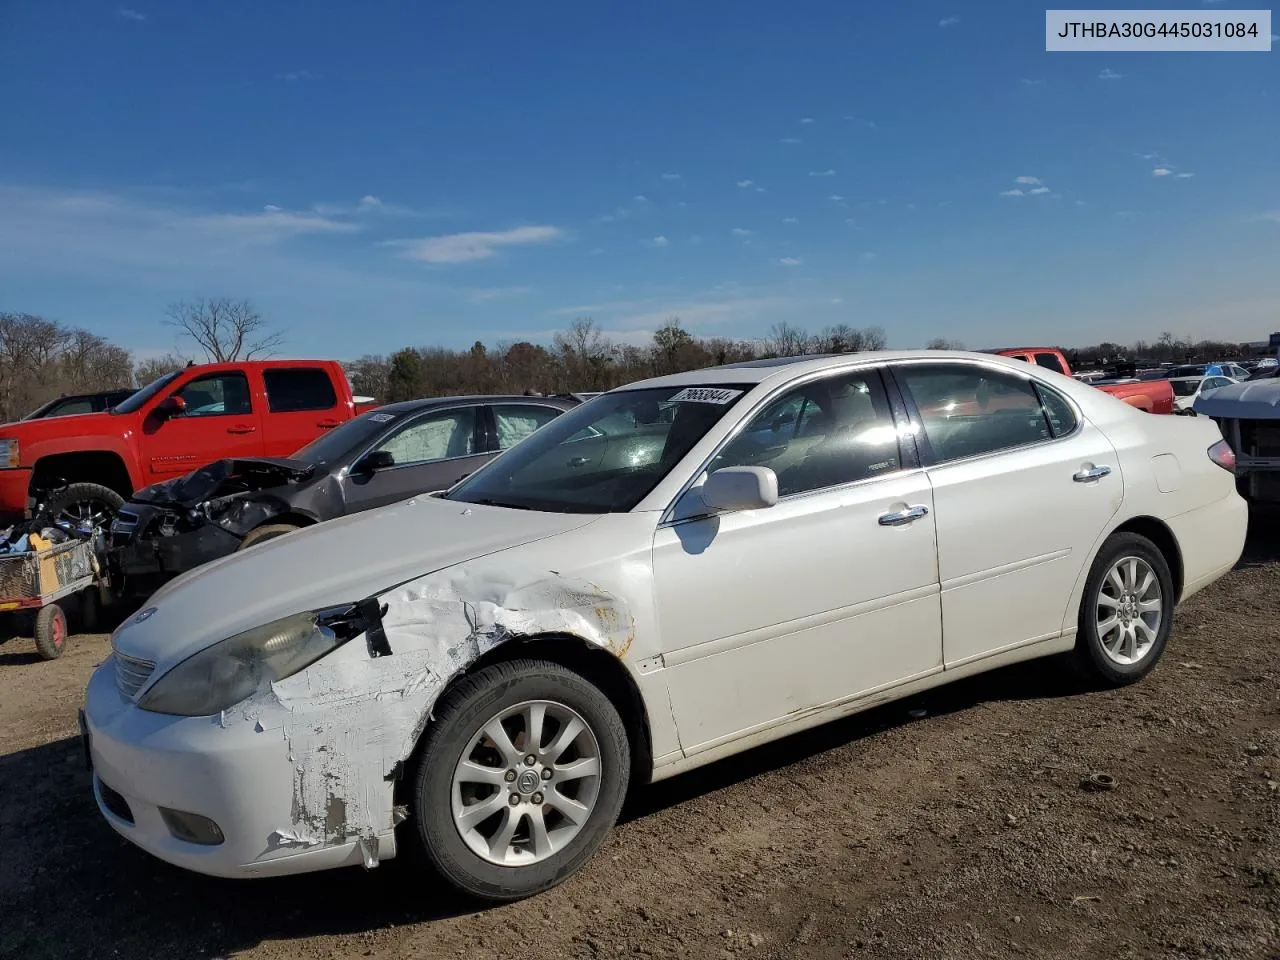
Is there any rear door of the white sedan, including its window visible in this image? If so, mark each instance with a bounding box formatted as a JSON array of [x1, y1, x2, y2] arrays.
[[892, 361, 1124, 667]]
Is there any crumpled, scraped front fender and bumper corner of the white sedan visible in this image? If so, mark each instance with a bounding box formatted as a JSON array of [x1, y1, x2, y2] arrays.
[[236, 564, 635, 867]]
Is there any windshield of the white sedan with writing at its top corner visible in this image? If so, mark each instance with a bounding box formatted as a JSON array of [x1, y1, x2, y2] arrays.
[[445, 384, 753, 513]]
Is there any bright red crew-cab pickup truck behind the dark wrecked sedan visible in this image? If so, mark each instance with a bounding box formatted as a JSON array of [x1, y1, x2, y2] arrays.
[[0, 360, 365, 524]]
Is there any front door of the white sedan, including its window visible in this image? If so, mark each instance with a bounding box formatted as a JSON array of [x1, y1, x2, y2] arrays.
[[653, 367, 942, 753]]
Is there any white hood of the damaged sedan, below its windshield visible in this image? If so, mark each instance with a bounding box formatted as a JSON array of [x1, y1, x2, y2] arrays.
[[111, 497, 599, 663]]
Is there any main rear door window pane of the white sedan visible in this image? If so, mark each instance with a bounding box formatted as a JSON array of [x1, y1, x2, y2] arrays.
[[897, 364, 1053, 462]]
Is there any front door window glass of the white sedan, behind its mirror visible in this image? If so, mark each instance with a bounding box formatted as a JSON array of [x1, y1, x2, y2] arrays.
[[710, 370, 901, 497]]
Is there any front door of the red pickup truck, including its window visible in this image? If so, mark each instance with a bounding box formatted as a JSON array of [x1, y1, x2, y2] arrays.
[[141, 370, 262, 484]]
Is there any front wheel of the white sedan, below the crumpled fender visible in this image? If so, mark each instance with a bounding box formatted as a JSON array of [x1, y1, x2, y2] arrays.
[[413, 660, 631, 902]]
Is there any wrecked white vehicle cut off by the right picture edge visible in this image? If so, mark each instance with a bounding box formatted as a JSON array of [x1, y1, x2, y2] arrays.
[[1194, 378, 1280, 503]]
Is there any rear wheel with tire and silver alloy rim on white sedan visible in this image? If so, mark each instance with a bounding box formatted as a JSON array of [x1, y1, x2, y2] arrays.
[[1075, 534, 1174, 686]]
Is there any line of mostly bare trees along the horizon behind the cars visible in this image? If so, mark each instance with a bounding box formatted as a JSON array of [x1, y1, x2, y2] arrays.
[[0, 297, 1269, 422]]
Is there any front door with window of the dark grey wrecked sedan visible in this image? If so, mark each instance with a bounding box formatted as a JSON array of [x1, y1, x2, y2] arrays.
[[342, 404, 494, 513]]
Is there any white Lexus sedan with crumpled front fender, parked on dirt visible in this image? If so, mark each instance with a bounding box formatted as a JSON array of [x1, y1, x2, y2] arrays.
[[82, 351, 1247, 900]]
